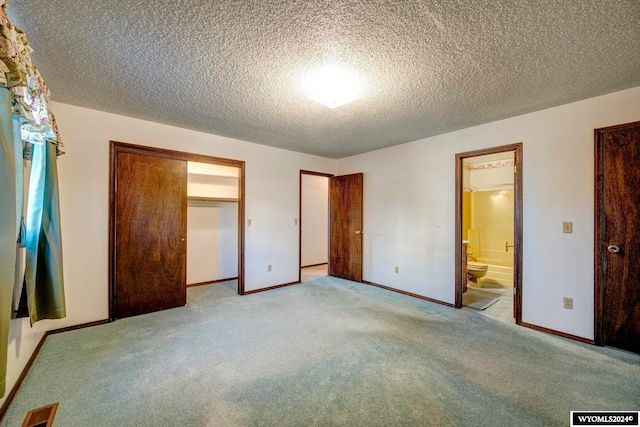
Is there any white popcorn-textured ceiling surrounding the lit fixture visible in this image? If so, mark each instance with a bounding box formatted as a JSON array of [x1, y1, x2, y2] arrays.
[[8, 0, 640, 158]]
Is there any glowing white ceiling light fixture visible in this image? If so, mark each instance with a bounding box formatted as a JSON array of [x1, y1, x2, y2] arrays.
[[302, 65, 362, 109]]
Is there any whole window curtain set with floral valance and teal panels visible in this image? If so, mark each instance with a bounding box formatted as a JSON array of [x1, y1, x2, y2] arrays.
[[0, 0, 65, 397]]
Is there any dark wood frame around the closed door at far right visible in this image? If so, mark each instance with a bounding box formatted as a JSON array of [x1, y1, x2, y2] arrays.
[[593, 122, 640, 346]]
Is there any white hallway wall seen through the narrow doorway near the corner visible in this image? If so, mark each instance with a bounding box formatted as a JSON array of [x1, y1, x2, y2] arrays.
[[301, 174, 329, 266]]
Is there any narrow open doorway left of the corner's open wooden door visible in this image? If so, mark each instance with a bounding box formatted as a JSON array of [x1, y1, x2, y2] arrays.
[[299, 170, 333, 282]]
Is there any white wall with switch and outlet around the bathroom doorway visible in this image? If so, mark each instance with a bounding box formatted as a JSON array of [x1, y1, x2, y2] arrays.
[[338, 87, 640, 339]]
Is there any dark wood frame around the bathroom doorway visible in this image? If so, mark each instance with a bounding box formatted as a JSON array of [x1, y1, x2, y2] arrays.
[[455, 142, 522, 325]]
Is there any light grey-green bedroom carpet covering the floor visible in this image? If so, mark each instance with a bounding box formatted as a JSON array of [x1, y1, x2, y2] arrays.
[[0, 277, 640, 427]]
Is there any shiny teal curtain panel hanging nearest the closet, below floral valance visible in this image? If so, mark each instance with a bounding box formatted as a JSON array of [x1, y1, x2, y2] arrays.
[[25, 143, 66, 323]]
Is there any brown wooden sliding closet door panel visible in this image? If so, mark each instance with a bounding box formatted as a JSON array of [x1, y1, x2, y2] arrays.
[[114, 152, 187, 318]]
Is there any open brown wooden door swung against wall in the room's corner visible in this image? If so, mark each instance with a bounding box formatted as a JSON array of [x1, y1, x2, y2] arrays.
[[329, 173, 363, 282]]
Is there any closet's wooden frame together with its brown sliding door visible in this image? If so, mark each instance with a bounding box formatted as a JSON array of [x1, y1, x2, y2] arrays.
[[109, 141, 244, 321]]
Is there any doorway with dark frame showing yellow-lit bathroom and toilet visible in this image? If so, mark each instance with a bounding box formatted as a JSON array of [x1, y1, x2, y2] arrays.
[[455, 143, 522, 324]]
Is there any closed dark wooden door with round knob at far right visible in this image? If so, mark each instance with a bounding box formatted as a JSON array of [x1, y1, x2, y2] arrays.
[[596, 122, 640, 353]]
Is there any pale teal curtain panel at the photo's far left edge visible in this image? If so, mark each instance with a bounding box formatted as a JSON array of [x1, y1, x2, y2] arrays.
[[0, 87, 22, 397]]
